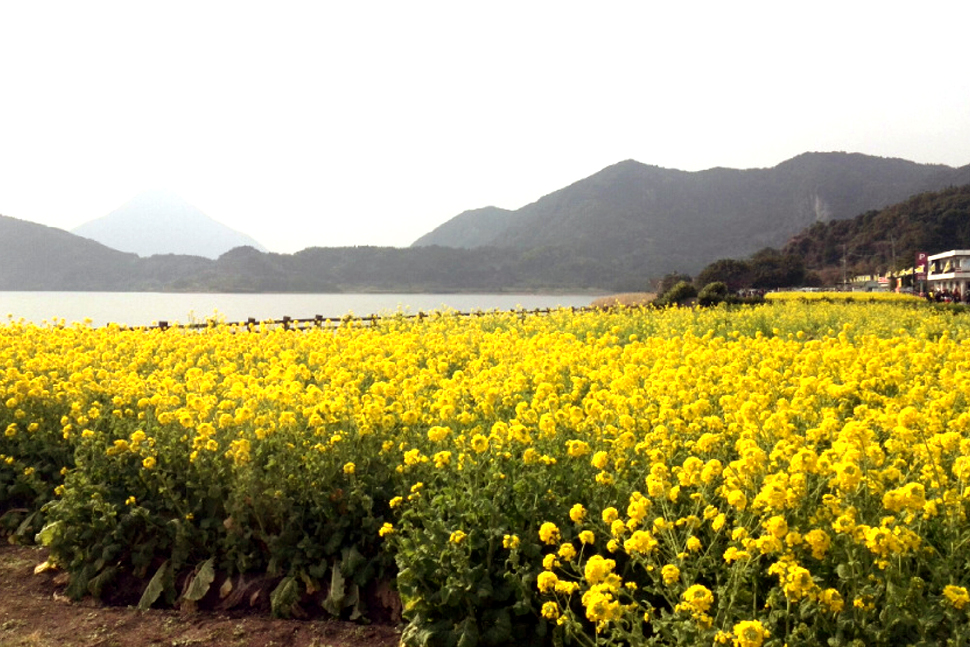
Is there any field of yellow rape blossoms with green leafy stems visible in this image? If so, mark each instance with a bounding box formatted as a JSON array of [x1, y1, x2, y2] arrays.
[[0, 299, 970, 647]]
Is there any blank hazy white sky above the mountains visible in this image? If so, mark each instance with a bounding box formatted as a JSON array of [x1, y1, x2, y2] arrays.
[[0, 0, 970, 252]]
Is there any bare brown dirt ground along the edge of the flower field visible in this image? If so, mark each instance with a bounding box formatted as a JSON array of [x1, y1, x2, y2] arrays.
[[0, 544, 400, 647]]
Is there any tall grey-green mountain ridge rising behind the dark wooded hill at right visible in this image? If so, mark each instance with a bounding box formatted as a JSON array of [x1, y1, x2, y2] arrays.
[[414, 153, 970, 276]]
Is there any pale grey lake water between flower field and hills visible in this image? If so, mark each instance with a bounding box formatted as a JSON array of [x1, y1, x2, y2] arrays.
[[0, 292, 595, 326]]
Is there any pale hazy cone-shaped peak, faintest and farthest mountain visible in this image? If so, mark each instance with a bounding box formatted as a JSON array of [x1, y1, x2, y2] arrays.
[[71, 190, 266, 259]]
